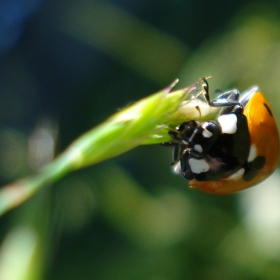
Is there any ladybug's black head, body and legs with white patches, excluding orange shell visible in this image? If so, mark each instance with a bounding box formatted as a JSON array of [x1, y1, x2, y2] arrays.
[[169, 79, 265, 184]]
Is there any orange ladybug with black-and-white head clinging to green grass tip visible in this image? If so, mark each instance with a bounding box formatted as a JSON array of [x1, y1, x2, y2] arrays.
[[168, 78, 279, 194]]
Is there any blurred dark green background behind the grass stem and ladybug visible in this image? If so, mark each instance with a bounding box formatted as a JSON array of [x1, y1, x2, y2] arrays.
[[0, 0, 280, 280]]
